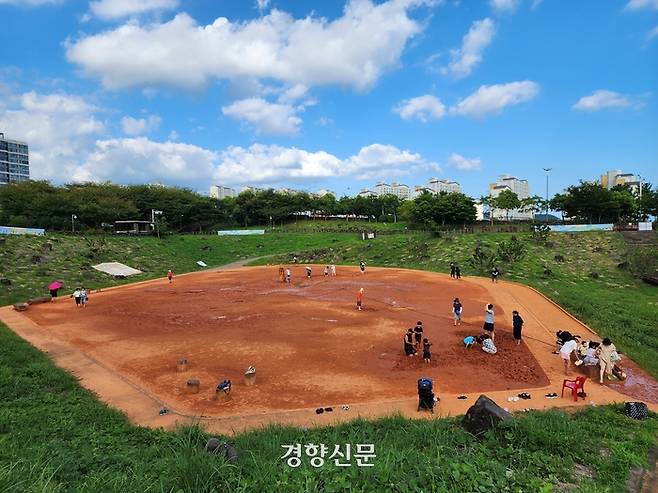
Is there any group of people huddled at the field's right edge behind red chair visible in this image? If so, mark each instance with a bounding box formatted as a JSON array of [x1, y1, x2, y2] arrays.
[[554, 330, 626, 384]]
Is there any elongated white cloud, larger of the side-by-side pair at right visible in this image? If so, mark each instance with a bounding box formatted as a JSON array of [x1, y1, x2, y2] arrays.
[[450, 80, 539, 118]]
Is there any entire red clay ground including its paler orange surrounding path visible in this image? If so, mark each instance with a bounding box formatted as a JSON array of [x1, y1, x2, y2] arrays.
[[0, 266, 658, 433]]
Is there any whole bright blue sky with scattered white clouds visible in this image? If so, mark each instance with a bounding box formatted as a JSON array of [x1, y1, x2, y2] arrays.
[[0, 0, 658, 197]]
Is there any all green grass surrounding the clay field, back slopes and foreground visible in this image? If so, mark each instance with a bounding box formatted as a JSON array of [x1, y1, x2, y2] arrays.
[[0, 223, 658, 492]]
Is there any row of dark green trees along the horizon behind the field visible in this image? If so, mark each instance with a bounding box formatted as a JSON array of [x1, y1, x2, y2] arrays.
[[0, 181, 658, 232]]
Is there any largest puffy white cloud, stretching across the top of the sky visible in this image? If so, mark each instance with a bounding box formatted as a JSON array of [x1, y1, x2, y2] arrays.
[[66, 0, 432, 90]]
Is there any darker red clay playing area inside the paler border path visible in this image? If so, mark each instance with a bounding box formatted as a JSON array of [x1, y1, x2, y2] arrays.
[[18, 266, 549, 415]]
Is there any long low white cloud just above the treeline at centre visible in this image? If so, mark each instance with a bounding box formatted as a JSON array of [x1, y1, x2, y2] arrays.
[[213, 144, 438, 185]]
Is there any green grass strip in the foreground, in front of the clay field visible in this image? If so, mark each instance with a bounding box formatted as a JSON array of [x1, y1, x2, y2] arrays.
[[0, 320, 658, 492]]
